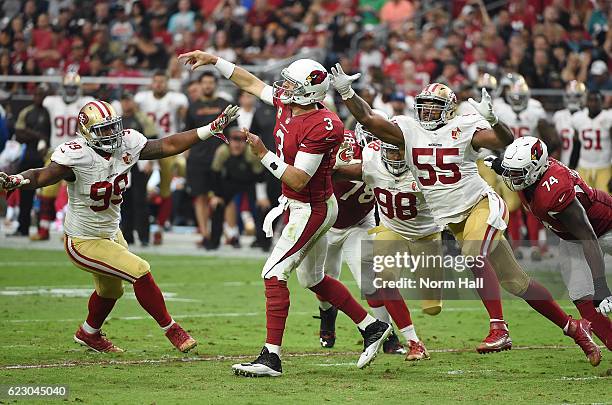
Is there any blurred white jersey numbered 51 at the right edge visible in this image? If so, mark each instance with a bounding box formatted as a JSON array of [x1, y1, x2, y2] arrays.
[[572, 108, 612, 169]]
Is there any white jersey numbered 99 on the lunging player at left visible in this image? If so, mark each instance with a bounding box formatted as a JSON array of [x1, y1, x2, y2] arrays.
[[51, 129, 147, 239]]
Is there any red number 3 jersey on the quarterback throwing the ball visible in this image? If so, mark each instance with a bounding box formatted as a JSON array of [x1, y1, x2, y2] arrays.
[[274, 98, 344, 203]]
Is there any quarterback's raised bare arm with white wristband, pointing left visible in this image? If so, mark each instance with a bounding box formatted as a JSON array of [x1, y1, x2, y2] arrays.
[[178, 51, 272, 105]]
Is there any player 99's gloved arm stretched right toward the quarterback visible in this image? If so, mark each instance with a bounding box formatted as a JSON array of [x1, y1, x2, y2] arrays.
[[140, 105, 239, 160]]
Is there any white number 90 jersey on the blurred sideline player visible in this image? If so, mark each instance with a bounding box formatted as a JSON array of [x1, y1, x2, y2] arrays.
[[43, 95, 94, 150]]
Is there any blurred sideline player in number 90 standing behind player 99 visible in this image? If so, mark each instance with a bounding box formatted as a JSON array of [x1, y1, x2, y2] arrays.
[[30, 72, 94, 241]]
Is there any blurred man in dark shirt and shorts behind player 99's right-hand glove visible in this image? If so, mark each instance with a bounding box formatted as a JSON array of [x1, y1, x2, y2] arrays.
[[185, 71, 229, 247]]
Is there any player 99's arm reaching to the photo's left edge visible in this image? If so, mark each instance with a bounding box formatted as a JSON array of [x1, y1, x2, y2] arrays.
[[0, 162, 74, 192]]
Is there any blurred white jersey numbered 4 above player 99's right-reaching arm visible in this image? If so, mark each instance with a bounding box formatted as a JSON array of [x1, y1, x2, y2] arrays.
[[134, 90, 189, 138]]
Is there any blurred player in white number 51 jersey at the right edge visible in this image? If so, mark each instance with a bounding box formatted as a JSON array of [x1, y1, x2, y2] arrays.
[[572, 92, 612, 192]]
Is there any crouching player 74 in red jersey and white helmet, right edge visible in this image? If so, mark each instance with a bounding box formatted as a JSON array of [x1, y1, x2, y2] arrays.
[[487, 136, 612, 350]]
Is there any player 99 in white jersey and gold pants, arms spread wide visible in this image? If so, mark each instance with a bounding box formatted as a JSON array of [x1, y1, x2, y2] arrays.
[[0, 100, 238, 352]]
